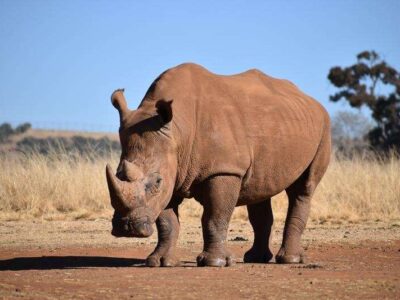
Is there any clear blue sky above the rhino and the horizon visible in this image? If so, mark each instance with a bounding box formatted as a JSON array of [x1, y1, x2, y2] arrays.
[[0, 0, 400, 131]]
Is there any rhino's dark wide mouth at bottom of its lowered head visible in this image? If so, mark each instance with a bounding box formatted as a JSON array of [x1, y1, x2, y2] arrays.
[[111, 217, 154, 238]]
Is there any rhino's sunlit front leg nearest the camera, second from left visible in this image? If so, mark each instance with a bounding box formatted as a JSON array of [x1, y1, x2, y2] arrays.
[[197, 176, 241, 267]]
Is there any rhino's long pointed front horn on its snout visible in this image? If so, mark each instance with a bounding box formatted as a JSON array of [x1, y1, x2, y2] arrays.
[[106, 164, 134, 211]]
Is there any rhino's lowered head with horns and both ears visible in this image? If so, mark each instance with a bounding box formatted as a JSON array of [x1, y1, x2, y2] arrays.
[[106, 90, 177, 237]]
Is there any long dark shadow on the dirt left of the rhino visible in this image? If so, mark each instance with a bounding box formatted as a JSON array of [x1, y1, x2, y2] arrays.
[[0, 256, 145, 271]]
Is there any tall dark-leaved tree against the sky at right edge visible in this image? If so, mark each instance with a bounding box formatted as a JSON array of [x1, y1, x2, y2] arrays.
[[328, 51, 400, 151]]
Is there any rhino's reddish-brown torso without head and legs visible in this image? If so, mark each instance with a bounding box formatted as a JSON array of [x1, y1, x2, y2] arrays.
[[145, 64, 329, 202]]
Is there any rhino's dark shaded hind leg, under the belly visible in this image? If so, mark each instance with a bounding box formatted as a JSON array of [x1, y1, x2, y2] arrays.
[[243, 198, 274, 263]]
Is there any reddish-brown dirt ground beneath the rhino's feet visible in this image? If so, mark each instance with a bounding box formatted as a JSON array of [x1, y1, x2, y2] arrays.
[[0, 220, 400, 299]]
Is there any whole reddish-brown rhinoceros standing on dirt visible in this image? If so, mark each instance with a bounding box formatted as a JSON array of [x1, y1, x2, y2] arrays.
[[106, 63, 331, 267]]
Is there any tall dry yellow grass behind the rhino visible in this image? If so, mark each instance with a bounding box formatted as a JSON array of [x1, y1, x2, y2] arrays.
[[0, 154, 400, 223]]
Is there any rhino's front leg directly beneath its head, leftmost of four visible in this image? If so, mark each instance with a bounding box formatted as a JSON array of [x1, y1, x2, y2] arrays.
[[146, 206, 180, 267]]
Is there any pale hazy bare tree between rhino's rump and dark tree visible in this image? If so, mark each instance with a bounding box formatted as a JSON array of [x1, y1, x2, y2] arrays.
[[332, 111, 373, 157]]
